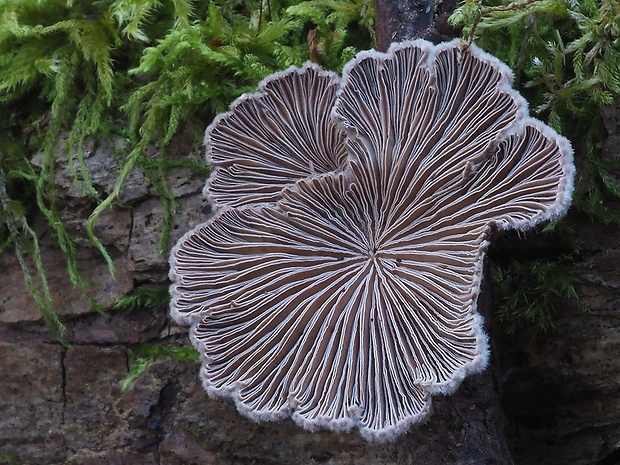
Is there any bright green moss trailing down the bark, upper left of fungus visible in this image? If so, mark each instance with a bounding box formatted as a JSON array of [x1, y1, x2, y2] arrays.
[[0, 0, 373, 337]]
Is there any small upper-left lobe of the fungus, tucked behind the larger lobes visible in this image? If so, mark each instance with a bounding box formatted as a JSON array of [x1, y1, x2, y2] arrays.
[[205, 63, 346, 206]]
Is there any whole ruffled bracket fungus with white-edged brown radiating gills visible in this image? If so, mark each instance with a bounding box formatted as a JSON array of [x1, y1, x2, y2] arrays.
[[170, 40, 574, 441]]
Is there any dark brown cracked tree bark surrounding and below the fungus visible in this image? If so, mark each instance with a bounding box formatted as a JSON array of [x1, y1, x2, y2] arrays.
[[0, 7, 620, 465]]
